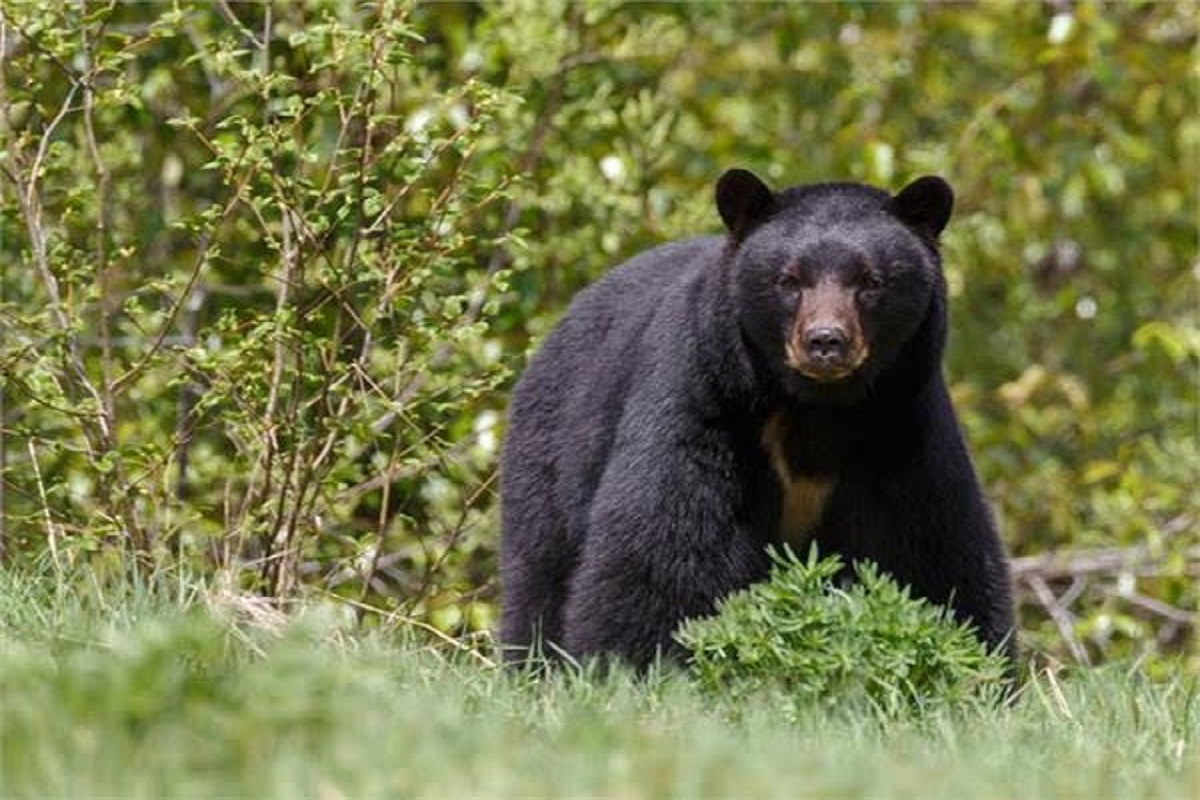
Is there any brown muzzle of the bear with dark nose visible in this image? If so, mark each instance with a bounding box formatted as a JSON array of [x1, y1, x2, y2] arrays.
[[784, 275, 870, 384]]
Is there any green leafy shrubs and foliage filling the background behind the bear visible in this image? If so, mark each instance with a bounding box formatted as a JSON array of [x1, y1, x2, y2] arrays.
[[0, 0, 1200, 668]]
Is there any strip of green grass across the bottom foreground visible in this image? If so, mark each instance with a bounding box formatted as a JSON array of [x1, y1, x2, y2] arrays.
[[0, 576, 1200, 800]]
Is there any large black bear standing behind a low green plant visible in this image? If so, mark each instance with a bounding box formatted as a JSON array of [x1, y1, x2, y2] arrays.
[[500, 169, 1013, 666]]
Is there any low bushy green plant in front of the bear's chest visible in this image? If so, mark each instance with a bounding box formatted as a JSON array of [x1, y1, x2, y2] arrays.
[[677, 548, 1007, 712]]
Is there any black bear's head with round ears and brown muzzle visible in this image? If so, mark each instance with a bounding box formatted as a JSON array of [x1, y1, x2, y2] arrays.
[[716, 169, 954, 403]]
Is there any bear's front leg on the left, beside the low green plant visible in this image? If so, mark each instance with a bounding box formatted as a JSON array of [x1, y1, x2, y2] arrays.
[[563, 455, 768, 668]]
